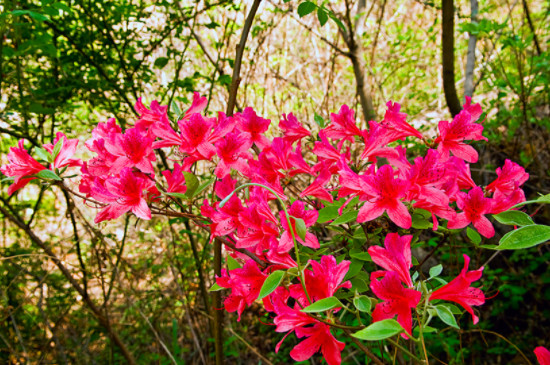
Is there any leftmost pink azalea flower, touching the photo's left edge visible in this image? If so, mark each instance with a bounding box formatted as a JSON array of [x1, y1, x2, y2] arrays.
[[0, 139, 46, 195]]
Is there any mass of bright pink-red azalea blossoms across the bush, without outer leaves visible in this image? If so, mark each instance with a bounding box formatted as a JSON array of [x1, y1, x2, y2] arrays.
[[1, 93, 528, 364]]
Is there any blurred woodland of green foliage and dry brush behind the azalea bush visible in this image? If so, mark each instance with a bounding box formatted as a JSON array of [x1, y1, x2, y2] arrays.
[[0, 0, 550, 364]]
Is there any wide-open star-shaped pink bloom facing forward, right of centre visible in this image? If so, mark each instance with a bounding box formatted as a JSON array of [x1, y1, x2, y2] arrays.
[[357, 165, 412, 229]]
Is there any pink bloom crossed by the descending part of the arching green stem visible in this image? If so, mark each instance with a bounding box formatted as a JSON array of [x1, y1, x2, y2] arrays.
[[279, 200, 321, 252]]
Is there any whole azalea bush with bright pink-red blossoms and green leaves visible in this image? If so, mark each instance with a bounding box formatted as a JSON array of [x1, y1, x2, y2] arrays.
[[0, 93, 550, 365]]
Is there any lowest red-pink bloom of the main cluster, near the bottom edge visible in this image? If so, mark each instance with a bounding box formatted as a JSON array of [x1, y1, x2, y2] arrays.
[[290, 322, 346, 365]]
